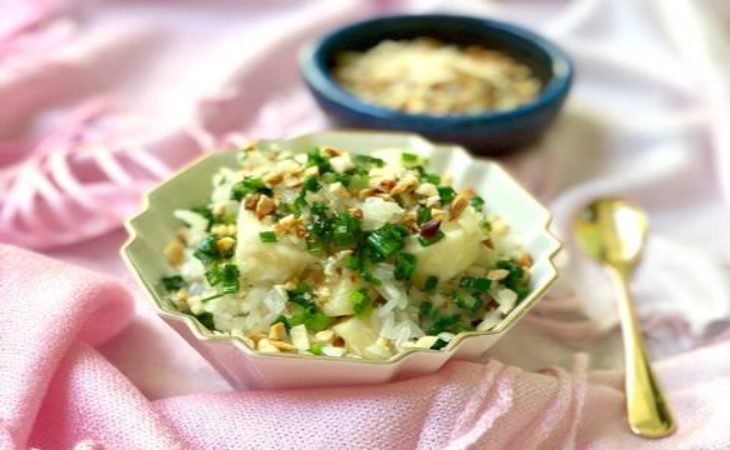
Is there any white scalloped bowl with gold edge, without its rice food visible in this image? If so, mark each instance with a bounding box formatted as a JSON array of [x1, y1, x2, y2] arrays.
[[122, 131, 561, 389]]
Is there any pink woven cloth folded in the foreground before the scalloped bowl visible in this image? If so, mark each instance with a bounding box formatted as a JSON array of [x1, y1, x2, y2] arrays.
[[0, 246, 730, 450]]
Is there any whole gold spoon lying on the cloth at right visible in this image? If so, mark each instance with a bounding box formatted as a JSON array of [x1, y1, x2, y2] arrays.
[[574, 198, 676, 438]]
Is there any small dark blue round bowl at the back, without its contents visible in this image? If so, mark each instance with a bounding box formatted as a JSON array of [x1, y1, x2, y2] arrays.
[[300, 14, 573, 154]]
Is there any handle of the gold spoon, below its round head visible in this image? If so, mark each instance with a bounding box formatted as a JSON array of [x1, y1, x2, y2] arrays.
[[609, 268, 676, 438]]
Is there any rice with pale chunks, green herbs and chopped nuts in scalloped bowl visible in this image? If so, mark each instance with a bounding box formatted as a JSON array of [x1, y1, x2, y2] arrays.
[[162, 145, 532, 360]]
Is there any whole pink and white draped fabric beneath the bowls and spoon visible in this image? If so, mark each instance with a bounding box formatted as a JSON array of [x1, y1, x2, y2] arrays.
[[0, 0, 730, 449]]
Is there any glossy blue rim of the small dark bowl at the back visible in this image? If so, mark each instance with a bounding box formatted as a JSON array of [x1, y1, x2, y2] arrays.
[[299, 14, 573, 128]]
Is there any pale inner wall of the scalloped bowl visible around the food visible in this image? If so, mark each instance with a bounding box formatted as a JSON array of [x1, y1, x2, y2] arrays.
[[122, 132, 560, 363]]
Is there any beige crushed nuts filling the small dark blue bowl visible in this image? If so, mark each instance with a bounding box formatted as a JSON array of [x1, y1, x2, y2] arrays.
[[334, 38, 541, 115]]
